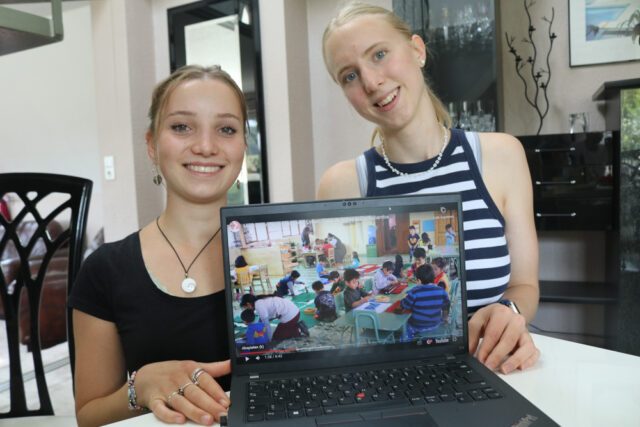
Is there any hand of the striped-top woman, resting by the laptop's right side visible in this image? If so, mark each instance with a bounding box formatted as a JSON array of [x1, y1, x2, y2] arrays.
[[469, 304, 540, 374]]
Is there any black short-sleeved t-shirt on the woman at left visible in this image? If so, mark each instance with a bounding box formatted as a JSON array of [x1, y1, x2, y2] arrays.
[[69, 233, 229, 390]]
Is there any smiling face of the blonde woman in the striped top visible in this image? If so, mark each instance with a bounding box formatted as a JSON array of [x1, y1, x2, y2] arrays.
[[324, 15, 429, 130]]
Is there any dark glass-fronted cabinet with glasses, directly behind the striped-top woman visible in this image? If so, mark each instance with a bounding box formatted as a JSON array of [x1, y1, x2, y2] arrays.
[[393, 0, 500, 131]]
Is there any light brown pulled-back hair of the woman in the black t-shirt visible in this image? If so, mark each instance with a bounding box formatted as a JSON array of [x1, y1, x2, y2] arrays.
[[148, 65, 247, 138]]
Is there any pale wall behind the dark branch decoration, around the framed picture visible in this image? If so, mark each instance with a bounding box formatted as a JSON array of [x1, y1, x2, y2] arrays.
[[499, 0, 640, 135]]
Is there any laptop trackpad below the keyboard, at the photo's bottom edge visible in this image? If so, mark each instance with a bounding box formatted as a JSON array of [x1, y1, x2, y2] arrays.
[[316, 408, 438, 427]]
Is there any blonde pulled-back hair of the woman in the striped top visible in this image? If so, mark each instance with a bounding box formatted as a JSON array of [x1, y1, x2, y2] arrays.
[[322, 1, 451, 145]]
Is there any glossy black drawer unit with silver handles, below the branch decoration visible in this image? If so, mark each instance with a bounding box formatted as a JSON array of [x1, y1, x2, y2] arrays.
[[518, 132, 614, 231]]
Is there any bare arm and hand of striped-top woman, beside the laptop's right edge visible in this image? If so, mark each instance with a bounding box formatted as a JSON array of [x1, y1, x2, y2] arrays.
[[469, 134, 539, 373]]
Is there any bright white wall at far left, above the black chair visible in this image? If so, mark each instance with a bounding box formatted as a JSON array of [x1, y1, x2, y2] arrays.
[[0, 1, 103, 244]]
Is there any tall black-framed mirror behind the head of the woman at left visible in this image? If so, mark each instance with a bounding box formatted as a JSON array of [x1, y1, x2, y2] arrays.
[[167, 0, 269, 205]]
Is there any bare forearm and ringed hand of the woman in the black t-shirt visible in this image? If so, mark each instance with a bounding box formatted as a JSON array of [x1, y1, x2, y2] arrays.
[[73, 310, 231, 427]]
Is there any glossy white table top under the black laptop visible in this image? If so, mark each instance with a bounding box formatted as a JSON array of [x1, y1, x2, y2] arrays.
[[105, 335, 640, 427]]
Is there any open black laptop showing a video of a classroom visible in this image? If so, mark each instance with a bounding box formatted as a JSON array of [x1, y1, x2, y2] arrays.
[[221, 194, 557, 427]]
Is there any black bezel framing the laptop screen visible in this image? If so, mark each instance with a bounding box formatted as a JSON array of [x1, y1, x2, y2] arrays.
[[220, 193, 468, 375]]
